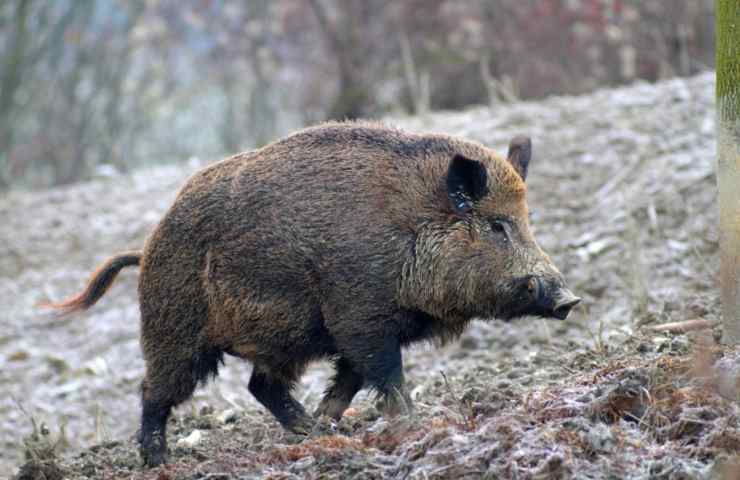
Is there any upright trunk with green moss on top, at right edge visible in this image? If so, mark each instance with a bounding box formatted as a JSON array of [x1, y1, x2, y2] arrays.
[[715, 0, 740, 345]]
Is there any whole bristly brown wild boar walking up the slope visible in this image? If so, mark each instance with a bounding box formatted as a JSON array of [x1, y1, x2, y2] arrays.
[[55, 122, 580, 466]]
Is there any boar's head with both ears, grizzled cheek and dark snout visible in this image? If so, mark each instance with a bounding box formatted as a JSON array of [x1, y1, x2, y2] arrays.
[[402, 137, 580, 320]]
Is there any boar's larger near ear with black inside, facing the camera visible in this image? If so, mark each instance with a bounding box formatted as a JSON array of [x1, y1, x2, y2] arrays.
[[447, 154, 488, 213]]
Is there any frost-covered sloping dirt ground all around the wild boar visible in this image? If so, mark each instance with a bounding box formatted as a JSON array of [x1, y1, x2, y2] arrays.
[[0, 74, 740, 480]]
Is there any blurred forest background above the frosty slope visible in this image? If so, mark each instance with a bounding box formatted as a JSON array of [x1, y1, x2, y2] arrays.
[[0, 0, 714, 191]]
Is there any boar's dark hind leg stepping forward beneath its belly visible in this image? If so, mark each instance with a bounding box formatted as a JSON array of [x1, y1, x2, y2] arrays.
[[248, 365, 313, 435]]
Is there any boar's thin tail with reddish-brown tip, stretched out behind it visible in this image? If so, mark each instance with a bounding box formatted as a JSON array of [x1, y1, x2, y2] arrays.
[[41, 252, 142, 314]]
